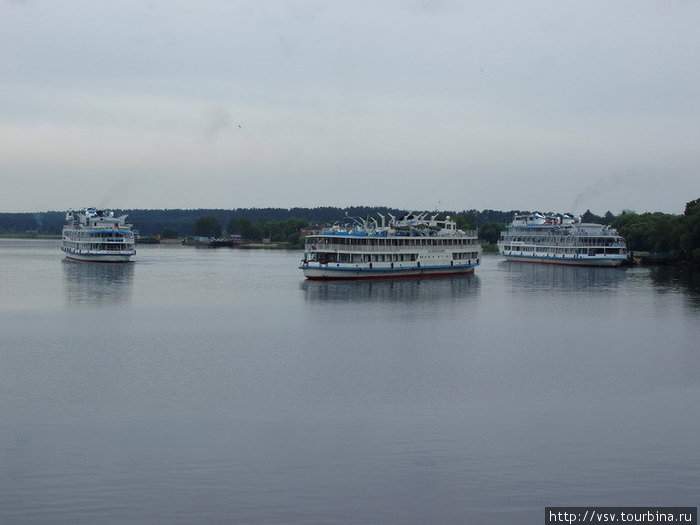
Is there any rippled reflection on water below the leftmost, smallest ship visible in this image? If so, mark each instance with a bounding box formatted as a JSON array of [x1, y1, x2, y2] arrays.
[[63, 260, 134, 307]]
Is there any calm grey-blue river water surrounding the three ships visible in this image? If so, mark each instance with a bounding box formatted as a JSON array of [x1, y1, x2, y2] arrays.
[[0, 240, 700, 524]]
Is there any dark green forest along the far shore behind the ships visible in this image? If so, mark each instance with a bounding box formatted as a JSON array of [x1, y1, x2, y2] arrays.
[[0, 199, 700, 264]]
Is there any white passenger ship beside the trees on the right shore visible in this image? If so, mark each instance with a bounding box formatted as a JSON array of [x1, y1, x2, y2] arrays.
[[498, 213, 628, 266]]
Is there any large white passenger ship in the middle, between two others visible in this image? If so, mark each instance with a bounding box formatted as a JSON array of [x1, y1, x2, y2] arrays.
[[299, 214, 481, 279]]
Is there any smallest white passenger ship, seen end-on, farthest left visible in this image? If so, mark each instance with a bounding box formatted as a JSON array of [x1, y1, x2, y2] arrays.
[[61, 208, 136, 262]]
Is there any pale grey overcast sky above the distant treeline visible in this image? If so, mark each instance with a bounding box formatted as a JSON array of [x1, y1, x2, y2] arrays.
[[0, 0, 700, 214]]
